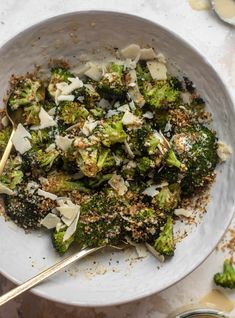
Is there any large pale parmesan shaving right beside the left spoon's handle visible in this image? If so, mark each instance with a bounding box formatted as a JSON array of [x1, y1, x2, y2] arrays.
[[12, 124, 32, 154]]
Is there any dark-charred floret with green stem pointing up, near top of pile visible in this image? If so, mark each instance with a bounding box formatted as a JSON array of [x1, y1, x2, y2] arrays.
[[97, 63, 126, 99]]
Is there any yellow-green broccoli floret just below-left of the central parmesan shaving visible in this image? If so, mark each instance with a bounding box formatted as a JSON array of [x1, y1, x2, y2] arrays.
[[101, 121, 127, 147]]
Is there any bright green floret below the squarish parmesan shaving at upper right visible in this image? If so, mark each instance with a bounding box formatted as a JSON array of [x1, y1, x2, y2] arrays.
[[142, 81, 179, 109]]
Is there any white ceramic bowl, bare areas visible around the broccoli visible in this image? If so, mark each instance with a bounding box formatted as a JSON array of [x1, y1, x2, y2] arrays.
[[0, 11, 235, 306]]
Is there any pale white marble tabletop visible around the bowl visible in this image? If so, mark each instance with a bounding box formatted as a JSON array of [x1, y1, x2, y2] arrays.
[[0, 0, 235, 318]]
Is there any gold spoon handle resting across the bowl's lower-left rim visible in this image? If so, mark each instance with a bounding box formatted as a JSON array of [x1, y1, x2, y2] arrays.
[[0, 247, 103, 306]]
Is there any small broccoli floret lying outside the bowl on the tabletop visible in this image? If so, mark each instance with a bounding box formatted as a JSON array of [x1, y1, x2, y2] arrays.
[[214, 259, 235, 289]]
